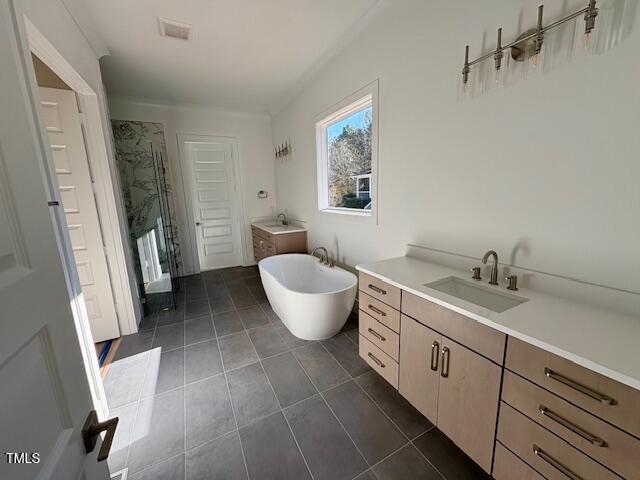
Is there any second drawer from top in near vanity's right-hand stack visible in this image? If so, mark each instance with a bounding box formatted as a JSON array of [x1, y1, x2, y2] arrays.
[[502, 370, 640, 480]]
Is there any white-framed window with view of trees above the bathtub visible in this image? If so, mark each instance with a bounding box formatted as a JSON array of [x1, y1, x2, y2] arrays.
[[316, 82, 378, 217]]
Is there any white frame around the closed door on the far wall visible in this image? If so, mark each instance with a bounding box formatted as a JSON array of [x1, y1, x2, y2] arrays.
[[177, 133, 246, 273]]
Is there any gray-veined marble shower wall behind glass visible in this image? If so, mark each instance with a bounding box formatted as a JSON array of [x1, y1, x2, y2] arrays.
[[111, 120, 183, 278]]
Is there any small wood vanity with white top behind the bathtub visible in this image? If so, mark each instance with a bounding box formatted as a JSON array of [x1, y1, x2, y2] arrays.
[[251, 223, 307, 262]]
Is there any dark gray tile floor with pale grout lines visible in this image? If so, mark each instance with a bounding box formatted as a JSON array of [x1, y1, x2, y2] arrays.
[[105, 267, 489, 480]]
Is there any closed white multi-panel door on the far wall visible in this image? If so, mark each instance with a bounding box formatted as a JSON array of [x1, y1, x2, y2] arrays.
[[181, 137, 242, 271]]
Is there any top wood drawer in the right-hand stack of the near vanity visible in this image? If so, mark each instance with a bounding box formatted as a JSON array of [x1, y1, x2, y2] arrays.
[[506, 337, 640, 437]]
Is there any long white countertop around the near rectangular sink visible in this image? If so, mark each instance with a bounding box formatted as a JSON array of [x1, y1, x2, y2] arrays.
[[356, 257, 640, 390]]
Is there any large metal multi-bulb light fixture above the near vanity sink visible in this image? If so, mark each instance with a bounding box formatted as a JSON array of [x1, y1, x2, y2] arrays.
[[462, 0, 598, 89]]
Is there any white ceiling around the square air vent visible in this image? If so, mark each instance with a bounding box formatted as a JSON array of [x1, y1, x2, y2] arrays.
[[85, 0, 379, 113]]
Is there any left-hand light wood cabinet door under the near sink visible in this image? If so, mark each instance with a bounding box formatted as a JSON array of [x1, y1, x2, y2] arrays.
[[399, 315, 442, 425]]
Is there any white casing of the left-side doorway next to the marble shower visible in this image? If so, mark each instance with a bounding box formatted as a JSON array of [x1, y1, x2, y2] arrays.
[[25, 17, 140, 335]]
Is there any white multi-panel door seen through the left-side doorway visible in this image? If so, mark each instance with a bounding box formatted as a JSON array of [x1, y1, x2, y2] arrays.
[[38, 87, 120, 342]]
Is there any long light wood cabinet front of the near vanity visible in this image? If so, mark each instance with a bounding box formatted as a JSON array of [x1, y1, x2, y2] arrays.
[[359, 271, 640, 480]]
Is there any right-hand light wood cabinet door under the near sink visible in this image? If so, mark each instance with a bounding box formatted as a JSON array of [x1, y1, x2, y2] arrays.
[[438, 338, 501, 472]]
